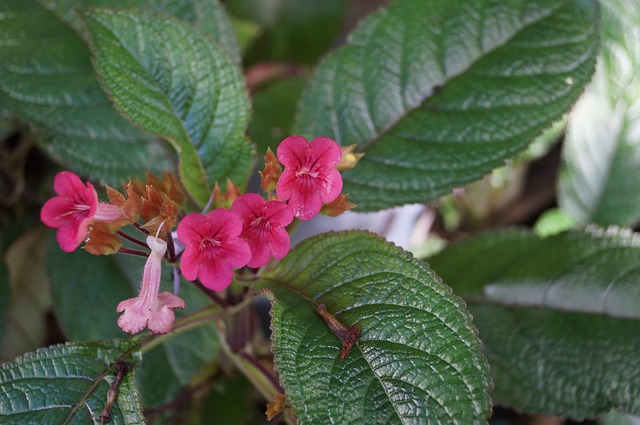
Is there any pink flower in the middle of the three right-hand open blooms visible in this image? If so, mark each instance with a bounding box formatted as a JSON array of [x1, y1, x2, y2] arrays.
[[231, 193, 293, 267]]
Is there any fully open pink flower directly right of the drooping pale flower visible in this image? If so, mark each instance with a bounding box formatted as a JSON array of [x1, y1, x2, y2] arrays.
[[178, 208, 251, 291]]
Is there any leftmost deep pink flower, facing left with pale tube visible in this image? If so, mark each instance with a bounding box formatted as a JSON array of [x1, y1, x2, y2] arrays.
[[40, 171, 122, 252]]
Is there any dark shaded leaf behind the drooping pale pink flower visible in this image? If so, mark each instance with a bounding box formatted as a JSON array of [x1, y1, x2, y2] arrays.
[[47, 242, 219, 408]]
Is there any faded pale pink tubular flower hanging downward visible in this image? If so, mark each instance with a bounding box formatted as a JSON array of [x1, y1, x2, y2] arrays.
[[116, 236, 185, 334]]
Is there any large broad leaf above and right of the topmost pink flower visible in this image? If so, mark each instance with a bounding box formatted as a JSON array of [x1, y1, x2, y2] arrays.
[[297, 0, 598, 210]]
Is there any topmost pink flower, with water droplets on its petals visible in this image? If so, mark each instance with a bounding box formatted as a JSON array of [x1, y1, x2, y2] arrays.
[[276, 136, 342, 220]]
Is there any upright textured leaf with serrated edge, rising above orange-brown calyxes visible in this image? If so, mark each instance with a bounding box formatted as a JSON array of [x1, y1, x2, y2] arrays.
[[84, 10, 253, 204]]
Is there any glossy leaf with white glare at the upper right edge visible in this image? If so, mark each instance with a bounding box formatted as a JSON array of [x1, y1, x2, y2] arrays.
[[558, 0, 640, 226]]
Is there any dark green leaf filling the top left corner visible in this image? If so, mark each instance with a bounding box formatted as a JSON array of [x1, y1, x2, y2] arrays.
[[0, 0, 171, 185]]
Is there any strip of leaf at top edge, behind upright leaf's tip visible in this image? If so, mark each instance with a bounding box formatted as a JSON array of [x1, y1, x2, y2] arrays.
[[40, 0, 240, 63]]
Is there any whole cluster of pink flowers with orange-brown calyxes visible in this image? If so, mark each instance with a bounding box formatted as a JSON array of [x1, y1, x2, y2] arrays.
[[41, 136, 360, 334]]
